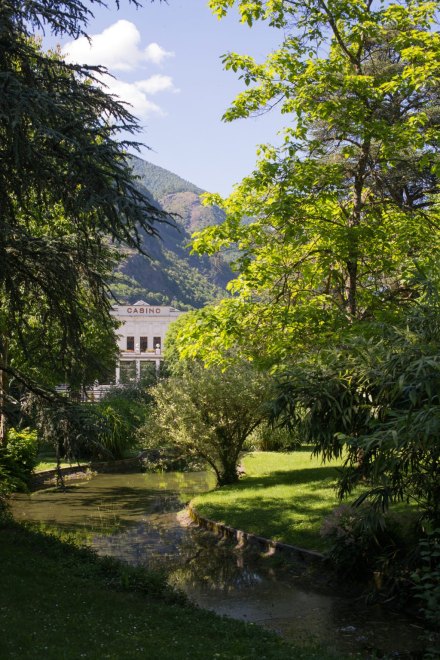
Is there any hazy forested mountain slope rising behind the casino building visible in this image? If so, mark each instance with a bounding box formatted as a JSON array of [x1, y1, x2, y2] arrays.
[[111, 156, 233, 309]]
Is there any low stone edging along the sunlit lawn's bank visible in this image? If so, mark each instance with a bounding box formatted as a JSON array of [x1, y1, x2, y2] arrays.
[[188, 503, 324, 563]]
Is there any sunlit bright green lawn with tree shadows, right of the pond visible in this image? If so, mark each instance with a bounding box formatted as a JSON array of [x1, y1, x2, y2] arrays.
[[192, 449, 346, 551]]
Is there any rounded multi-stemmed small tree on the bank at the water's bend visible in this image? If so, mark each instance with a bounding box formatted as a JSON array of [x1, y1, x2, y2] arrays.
[[146, 363, 269, 485]]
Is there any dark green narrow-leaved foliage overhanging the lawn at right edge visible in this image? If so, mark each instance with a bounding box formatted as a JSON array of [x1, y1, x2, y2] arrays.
[[274, 282, 440, 526]]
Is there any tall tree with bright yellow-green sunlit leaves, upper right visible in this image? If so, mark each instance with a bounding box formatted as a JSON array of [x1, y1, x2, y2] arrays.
[[175, 0, 440, 362]]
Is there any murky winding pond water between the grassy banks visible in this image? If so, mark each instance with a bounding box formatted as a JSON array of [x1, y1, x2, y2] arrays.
[[13, 472, 421, 658]]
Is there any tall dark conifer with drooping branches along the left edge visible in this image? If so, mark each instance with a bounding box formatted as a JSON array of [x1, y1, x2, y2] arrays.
[[0, 0, 164, 440]]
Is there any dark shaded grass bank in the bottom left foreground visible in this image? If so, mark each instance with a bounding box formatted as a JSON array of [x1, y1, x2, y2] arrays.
[[0, 524, 340, 660]]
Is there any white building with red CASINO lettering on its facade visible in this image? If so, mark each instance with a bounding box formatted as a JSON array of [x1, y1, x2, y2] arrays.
[[112, 300, 182, 383]]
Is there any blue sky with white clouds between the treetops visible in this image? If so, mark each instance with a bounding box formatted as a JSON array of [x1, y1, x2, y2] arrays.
[[46, 0, 285, 196]]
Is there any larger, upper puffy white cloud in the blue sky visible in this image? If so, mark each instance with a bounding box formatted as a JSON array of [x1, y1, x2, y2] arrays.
[[63, 20, 174, 71]]
